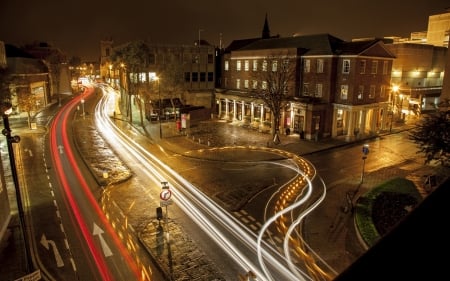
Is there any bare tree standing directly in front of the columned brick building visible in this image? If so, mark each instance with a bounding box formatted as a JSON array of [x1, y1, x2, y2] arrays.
[[253, 55, 296, 144]]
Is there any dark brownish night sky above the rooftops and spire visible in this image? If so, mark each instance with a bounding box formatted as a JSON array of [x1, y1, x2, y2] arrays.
[[0, 0, 450, 60]]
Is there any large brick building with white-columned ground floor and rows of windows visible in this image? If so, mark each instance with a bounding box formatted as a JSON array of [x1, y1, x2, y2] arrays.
[[215, 34, 395, 139]]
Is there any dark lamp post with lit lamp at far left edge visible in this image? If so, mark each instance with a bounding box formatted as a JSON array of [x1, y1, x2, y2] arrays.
[[1, 103, 33, 273]]
